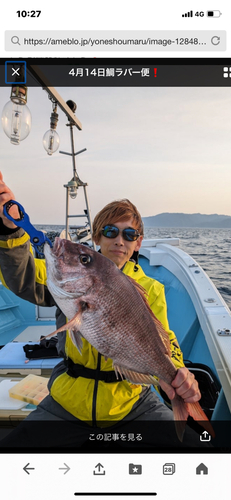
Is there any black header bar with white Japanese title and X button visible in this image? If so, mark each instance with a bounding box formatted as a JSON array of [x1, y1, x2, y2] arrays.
[[0, 58, 231, 87]]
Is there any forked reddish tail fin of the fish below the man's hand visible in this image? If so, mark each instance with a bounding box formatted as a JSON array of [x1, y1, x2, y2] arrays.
[[171, 395, 215, 442]]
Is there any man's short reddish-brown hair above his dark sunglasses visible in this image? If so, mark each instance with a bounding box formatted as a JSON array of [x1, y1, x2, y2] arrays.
[[93, 199, 144, 243]]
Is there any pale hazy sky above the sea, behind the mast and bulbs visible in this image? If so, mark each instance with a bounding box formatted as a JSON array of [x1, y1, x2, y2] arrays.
[[0, 87, 231, 224]]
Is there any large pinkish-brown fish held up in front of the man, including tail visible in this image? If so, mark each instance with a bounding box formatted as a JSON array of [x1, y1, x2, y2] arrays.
[[44, 238, 214, 441]]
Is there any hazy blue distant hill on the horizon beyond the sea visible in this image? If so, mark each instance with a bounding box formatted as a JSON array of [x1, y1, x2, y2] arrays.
[[143, 212, 231, 229]]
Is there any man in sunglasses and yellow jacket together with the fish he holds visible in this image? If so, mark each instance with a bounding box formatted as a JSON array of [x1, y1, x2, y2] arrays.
[[0, 175, 213, 446]]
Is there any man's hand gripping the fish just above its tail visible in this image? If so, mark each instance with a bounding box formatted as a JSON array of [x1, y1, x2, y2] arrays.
[[159, 367, 201, 403]]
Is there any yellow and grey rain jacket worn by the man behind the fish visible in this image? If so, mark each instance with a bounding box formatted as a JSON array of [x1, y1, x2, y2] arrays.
[[0, 230, 184, 425]]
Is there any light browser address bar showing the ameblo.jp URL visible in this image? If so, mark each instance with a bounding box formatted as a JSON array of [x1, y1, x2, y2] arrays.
[[5, 30, 226, 52]]
